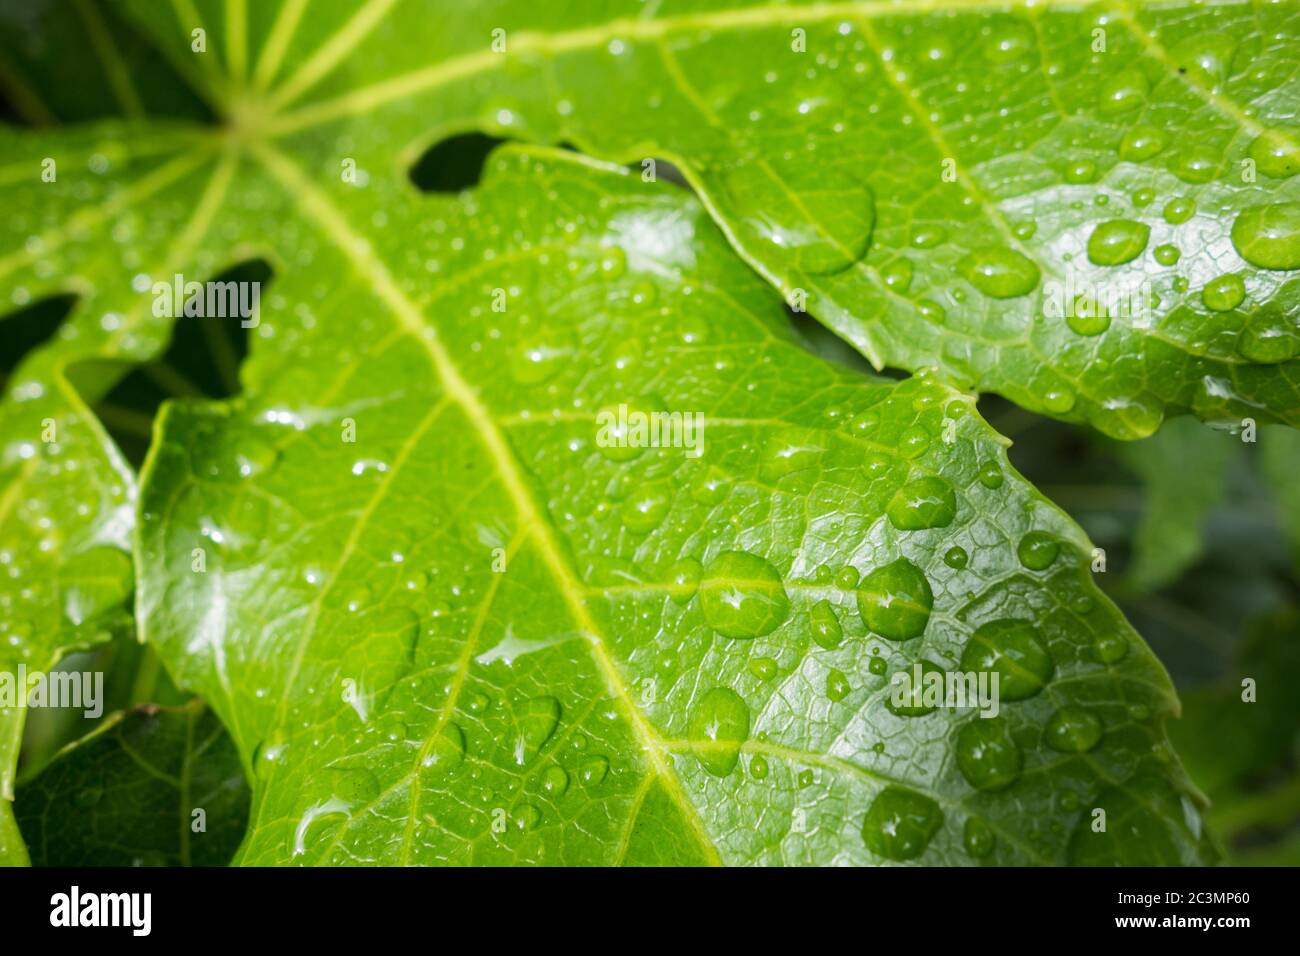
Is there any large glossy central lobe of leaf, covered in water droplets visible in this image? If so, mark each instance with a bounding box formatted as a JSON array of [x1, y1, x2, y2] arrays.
[[129, 138, 1208, 864]]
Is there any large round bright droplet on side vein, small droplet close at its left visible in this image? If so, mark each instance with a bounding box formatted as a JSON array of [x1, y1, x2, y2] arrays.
[[699, 551, 790, 639]]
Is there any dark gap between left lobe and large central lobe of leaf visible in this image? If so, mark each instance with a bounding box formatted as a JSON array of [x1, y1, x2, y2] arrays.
[[95, 259, 272, 466]]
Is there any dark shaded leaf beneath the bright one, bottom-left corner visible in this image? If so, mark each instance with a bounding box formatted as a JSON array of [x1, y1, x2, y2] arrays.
[[14, 701, 248, 866]]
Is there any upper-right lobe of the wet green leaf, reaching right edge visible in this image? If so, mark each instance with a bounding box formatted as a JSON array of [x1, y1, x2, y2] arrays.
[[119, 0, 1300, 438]]
